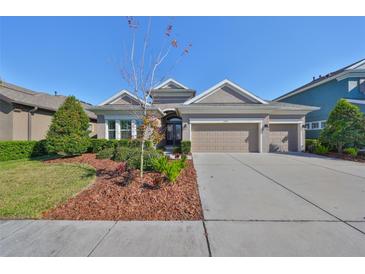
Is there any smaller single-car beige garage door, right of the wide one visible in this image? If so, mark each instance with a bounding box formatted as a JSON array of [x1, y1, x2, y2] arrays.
[[270, 124, 298, 152]]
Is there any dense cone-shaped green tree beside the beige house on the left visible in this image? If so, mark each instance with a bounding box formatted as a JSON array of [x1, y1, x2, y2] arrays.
[[46, 96, 90, 155]]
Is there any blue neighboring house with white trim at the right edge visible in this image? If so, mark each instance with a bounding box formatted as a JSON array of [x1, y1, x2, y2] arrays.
[[274, 59, 365, 138]]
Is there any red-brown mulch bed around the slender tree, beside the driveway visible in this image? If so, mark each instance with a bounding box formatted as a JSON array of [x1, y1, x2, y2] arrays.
[[43, 154, 202, 220]]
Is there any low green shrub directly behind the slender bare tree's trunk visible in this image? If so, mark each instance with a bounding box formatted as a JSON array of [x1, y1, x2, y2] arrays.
[[114, 147, 162, 170]]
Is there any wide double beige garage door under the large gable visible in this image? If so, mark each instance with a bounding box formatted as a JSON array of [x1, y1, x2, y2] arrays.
[[191, 124, 259, 152]]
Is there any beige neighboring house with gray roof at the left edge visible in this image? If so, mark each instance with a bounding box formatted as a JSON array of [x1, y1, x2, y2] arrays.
[[0, 81, 96, 140]]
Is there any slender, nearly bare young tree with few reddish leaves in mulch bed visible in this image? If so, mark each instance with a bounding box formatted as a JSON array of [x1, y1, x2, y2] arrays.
[[121, 17, 192, 178]]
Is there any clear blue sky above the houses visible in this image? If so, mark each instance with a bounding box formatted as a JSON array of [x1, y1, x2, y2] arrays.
[[0, 17, 365, 104]]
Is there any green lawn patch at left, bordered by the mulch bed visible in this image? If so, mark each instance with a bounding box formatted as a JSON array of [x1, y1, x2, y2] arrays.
[[0, 160, 95, 218]]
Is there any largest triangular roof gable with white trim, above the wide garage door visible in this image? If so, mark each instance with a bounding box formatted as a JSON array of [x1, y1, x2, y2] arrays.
[[184, 80, 267, 105]]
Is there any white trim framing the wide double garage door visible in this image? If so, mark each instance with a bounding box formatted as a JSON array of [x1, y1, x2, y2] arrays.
[[189, 118, 264, 153]]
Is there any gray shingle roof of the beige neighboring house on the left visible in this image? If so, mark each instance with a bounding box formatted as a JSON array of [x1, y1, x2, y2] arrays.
[[0, 82, 96, 119]]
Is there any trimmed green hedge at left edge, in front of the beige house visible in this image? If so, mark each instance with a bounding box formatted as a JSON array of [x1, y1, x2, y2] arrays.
[[0, 140, 47, 161]]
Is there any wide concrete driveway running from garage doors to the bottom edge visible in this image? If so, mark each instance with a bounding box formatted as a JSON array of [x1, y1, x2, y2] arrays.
[[194, 153, 365, 256]]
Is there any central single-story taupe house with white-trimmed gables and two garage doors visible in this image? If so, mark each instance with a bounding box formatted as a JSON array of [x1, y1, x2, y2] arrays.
[[89, 79, 318, 152]]
